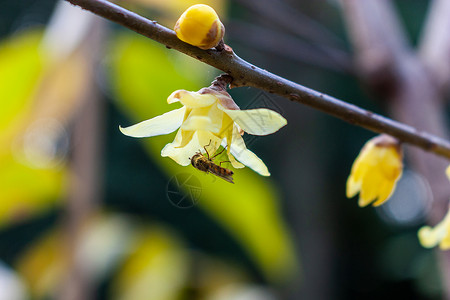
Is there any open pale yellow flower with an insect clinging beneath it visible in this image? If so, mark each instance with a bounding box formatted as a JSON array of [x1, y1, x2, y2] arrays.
[[119, 87, 287, 176]]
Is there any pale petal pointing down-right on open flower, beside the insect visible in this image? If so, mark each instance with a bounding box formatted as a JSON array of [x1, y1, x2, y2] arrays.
[[230, 129, 270, 176]]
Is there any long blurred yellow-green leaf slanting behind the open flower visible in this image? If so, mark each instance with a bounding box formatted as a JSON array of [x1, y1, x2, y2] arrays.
[[110, 34, 298, 281]]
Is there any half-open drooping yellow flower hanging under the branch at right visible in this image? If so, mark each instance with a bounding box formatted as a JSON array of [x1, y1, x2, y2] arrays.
[[347, 134, 403, 207]]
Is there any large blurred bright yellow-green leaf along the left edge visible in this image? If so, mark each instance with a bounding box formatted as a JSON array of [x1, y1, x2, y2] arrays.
[[0, 29, 66, 226]]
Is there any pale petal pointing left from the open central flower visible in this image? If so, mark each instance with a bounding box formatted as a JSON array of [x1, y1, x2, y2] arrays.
[[119, 107, 186, 137]]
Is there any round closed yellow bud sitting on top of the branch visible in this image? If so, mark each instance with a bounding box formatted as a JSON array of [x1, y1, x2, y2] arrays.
[[174, 4, 225, 50]]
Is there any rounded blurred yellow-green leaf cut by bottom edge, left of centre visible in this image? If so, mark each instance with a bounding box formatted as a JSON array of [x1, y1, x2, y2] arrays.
[[112, 226, 189, 300]]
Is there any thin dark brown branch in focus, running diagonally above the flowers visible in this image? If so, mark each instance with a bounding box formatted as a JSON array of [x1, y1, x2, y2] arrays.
[[66, 0, 450, 158]]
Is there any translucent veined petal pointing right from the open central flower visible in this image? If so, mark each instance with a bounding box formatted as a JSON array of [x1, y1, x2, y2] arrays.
[[219, 105, 287, 135]]
